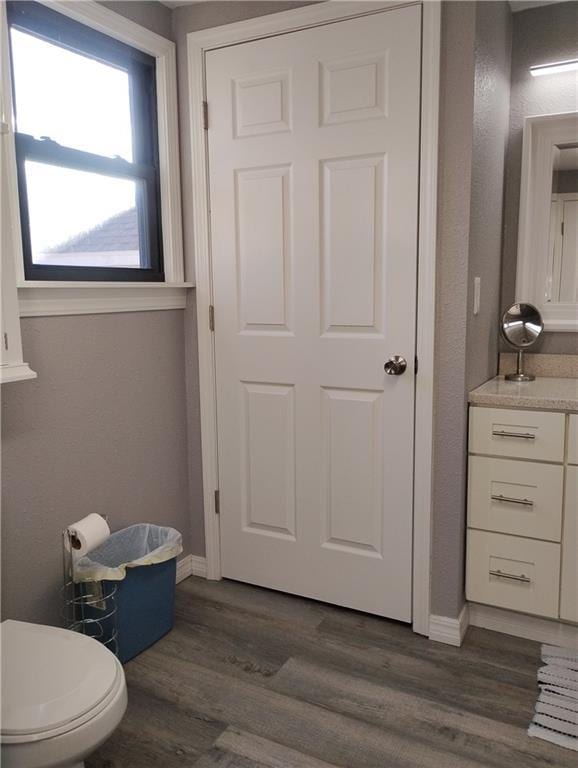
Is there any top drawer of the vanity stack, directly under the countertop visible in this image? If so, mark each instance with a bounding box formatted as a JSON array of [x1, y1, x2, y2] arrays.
[[470, 407, 566, 462]]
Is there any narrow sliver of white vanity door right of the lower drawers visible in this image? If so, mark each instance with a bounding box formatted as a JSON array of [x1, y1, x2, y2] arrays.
[[560, 467, 578, 622]]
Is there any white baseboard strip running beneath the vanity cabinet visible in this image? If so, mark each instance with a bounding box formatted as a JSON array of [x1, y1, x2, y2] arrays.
[[468, 603, 578, 648]]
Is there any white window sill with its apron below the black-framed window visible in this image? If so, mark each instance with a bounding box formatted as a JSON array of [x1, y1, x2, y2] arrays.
[[18, 281, 194, 317]]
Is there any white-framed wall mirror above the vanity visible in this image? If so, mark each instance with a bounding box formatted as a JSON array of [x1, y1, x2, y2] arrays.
[[516, 112, 578, 331]]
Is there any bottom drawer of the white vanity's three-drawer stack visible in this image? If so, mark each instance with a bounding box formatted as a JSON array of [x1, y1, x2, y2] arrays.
[[466, 530, 560, 618]]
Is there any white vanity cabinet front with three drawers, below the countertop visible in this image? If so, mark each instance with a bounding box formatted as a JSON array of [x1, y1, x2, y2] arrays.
[[466, 405, 578, 622]]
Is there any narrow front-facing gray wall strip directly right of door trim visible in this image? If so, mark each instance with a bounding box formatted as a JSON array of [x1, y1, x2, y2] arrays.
[[431, 2, 476, 616]]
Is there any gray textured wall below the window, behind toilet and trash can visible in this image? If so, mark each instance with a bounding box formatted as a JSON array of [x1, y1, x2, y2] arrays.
[[2, 311, 191, 623]]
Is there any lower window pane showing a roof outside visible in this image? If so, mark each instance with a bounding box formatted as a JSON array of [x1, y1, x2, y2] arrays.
[[24, 160, 142, 268]]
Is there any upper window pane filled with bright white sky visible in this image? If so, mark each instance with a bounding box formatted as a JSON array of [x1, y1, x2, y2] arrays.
[[10, 28, 133, 161]]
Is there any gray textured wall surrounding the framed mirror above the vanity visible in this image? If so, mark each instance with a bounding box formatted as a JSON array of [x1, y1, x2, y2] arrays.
[[502, 2, 578, 354]]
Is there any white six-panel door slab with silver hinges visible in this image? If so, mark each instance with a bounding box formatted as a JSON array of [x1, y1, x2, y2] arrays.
[[206, 6, 421, 621]]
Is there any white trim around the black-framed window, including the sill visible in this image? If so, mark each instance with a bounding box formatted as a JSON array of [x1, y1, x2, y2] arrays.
[[1, 0, 189, 317]]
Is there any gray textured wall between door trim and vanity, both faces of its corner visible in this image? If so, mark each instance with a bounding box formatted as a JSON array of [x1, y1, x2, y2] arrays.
[[432, 2, 511, 617]]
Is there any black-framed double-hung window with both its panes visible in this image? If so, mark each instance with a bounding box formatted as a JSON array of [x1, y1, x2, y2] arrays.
[[7, 2, 164, 281]]
